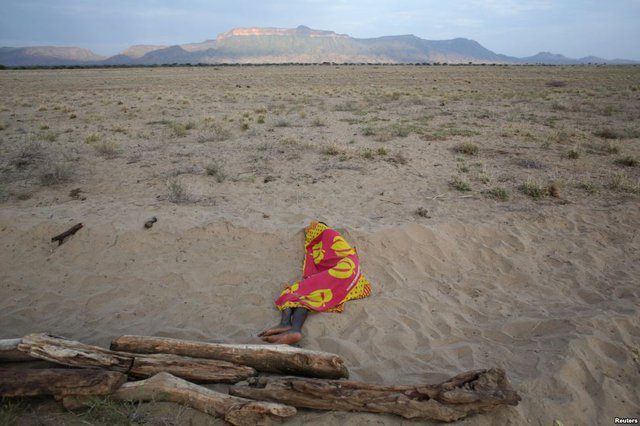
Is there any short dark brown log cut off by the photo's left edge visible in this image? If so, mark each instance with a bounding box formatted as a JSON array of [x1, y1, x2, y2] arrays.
[[0, 368, 127, 399]]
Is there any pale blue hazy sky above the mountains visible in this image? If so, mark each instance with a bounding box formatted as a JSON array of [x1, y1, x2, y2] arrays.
[[0, 0, 640, 60]]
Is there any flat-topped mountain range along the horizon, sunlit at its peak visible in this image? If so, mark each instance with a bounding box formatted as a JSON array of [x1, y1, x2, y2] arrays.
[[0, 26, 638, 67]]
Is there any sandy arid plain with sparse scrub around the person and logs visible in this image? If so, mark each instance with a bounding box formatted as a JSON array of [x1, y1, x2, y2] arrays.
[[0, 65, 640, 426]]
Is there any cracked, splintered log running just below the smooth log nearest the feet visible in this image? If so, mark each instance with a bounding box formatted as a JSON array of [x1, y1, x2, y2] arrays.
[[18, 334, 256, 383]]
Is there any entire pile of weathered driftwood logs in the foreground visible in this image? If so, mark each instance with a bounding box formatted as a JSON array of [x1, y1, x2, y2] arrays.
[[0, 334, 520, 425]]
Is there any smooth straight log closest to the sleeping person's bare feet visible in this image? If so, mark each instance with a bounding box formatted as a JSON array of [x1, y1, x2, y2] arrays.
[[111, 336, 349, 379]]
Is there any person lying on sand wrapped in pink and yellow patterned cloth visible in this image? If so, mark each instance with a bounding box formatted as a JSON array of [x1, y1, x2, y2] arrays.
[[258, 221, 371, 345]]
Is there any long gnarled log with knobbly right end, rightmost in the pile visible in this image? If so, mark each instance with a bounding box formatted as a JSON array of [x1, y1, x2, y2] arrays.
[[229, 369, 520, 422]]
